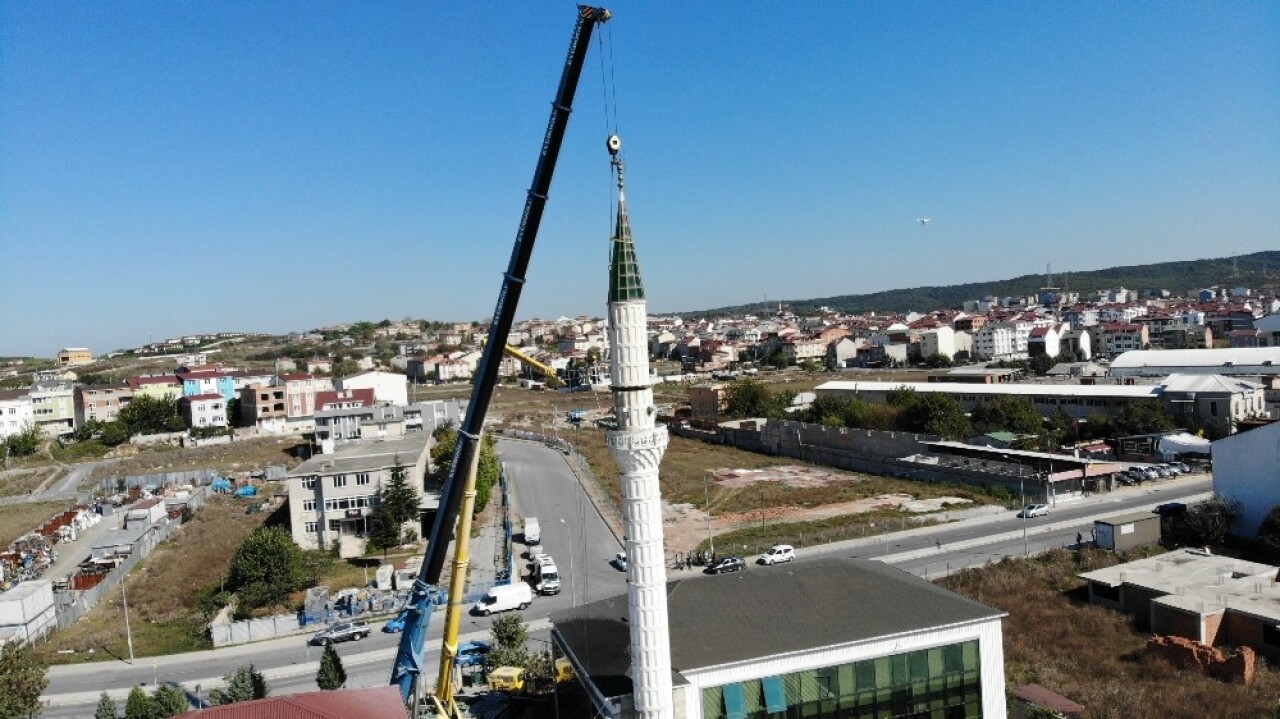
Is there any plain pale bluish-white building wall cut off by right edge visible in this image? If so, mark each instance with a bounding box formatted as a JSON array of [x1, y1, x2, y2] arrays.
[[1213, 422, 1280, 537]]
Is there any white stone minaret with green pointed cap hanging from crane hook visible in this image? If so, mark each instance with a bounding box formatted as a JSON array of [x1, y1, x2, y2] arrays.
[[607, 134, 673, 719]]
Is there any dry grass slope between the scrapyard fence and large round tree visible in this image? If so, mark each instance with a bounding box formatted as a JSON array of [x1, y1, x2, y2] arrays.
[[41, 495, 270, 663]]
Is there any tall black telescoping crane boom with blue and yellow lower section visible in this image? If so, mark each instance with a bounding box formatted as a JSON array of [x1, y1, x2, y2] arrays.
[[390, 5, 611, 716]]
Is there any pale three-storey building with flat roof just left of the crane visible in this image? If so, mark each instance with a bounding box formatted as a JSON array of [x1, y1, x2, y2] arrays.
[[288, 434, 439, 557]]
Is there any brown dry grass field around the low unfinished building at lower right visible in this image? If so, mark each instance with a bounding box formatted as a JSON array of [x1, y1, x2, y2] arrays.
[[937, 550, 1280, 719]]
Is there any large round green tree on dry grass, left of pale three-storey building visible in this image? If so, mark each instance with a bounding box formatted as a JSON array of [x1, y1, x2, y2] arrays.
[[227, 526, 307, 610]]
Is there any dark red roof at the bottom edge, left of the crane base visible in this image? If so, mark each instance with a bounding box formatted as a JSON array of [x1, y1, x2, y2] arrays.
[[178, 686, 408, 719]]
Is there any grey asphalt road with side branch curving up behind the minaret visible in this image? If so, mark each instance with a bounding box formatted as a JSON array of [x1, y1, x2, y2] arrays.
[[44, 441, 1212, 718]]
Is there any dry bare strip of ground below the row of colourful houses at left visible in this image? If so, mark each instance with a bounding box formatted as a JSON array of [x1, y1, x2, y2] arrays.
[[91, 438, 301, 481]]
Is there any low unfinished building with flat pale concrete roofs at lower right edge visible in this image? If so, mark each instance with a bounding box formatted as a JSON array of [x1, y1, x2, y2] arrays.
[[1080, 547, 1280, 661]]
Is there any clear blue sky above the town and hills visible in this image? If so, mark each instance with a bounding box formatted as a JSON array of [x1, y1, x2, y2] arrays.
[[0, 1, 1280, 356]]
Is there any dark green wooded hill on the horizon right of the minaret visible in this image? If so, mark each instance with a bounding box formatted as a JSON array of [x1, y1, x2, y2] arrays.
[[678, 251, 1280, 316]]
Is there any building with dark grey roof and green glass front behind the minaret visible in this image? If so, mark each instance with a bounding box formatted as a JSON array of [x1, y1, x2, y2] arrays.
[[552, 558, 1006, 719]]
